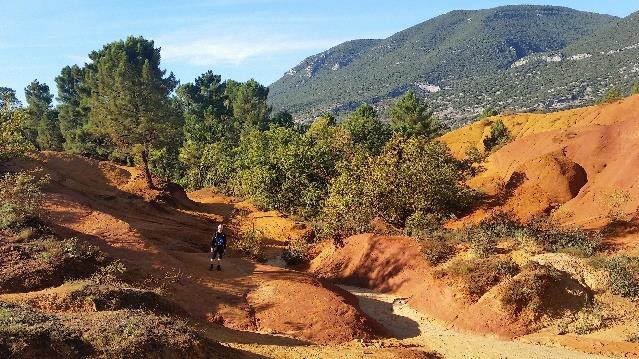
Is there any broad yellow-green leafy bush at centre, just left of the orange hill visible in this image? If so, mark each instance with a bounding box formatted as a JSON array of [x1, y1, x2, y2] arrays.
[[323, 136, 476, 233]]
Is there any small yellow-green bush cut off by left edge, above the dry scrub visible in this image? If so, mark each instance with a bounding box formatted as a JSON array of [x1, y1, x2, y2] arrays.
[[0, 172, 48, 229]]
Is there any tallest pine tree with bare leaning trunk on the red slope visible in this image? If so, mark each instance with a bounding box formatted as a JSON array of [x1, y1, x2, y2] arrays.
[[87, 37, 178, 188]]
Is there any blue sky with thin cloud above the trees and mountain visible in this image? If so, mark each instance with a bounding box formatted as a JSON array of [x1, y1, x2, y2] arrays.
[[0, 0, 639, 99]]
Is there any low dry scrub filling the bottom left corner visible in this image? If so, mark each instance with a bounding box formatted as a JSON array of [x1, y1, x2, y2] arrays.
[[0, 302, 221, 358]]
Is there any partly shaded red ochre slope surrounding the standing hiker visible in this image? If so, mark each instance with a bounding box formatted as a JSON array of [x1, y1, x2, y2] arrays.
[[5, 153, 382, 344]]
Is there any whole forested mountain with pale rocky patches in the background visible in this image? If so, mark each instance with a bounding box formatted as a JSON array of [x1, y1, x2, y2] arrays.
[[269, 5, 639, 125]]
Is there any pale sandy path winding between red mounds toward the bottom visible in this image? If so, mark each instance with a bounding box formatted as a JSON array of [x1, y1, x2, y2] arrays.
[[340, 286, 606, 359]]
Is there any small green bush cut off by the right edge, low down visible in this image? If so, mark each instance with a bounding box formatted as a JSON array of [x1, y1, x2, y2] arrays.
[[604, 256, 639, 300]]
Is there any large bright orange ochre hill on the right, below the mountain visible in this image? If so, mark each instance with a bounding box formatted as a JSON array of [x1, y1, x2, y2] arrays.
[[441, 96, 639, 227]]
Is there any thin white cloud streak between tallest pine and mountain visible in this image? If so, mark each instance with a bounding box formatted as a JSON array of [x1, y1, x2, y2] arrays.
[[157, 36, 339, 66]]
